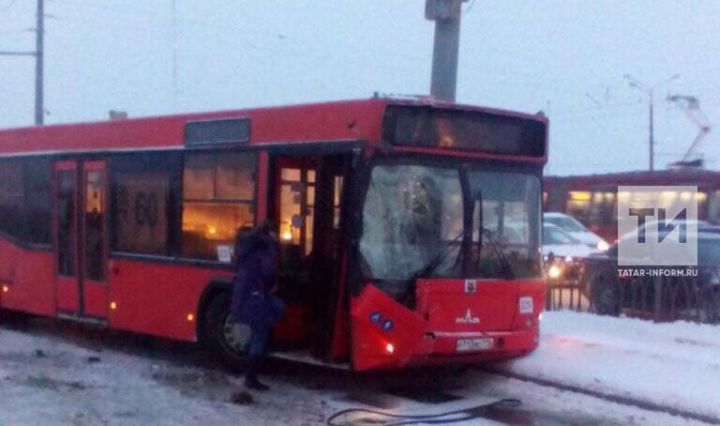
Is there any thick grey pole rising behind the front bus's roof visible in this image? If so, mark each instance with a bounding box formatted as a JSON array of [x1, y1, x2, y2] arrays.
[[425, 0, 466, 102]]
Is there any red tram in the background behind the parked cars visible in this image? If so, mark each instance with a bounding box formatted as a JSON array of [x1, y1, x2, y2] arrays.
[[543, 168, 720, 242]]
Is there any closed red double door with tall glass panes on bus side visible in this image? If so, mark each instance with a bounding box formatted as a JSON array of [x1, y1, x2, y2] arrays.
[[54, 160, 108, 320]]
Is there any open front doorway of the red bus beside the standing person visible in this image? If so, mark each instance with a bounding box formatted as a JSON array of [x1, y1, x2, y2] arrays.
[[269, 154, 351, 358]]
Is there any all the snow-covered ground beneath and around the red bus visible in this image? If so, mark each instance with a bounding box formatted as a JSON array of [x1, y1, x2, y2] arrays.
[[0, 312, 720, 426]]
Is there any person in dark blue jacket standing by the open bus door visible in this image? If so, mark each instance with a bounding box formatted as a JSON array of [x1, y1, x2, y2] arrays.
[[231, 221, 285, 391]]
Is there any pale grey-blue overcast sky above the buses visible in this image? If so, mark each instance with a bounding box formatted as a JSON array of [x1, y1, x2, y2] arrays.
[[0, 0, 720, 174]]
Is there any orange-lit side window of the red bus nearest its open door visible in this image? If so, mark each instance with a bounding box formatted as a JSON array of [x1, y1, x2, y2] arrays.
[[182, 152, 257, 263]]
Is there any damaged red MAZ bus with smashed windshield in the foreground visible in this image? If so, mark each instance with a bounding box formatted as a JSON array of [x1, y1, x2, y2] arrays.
[[0, 98, 547, 370]]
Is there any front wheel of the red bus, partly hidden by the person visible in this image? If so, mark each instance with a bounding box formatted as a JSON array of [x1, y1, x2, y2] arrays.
[[202, 291, 250, 365]]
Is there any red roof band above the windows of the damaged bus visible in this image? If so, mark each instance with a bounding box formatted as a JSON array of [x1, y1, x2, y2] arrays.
[[0, 98, 547, 156]]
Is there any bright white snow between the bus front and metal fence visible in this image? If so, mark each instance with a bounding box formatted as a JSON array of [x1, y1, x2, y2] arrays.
[[501, 311, 720, 418]]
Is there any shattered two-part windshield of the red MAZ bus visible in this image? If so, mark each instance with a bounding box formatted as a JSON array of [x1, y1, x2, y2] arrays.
[[360, 165, 540, 280]]
